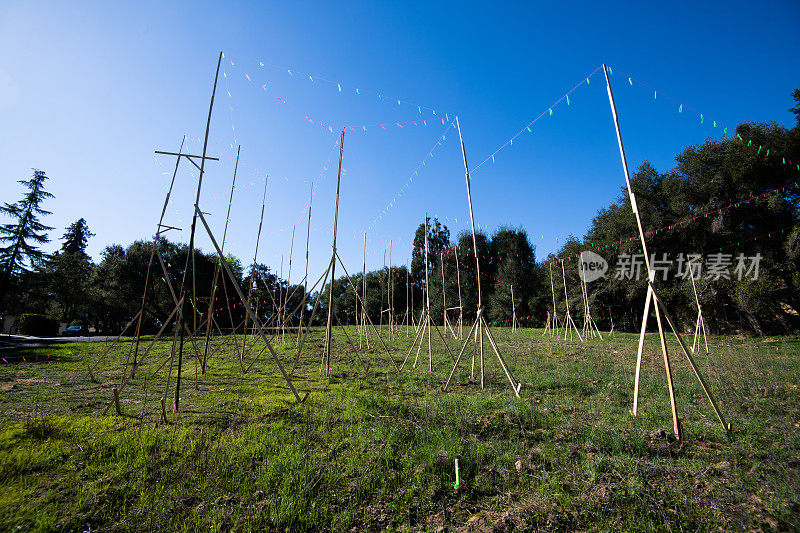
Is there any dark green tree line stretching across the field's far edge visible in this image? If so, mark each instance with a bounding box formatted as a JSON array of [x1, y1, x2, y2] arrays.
[[0, 89, 800, 334]]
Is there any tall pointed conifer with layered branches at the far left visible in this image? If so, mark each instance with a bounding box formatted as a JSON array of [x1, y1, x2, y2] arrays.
[[0, 169, 53, 302]]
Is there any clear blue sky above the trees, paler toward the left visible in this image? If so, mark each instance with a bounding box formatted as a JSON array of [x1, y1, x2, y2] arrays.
[[0, 0, 800, 281]]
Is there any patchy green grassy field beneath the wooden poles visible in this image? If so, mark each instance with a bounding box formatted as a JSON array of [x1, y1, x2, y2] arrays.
[[0, 322, 800, 531]]
